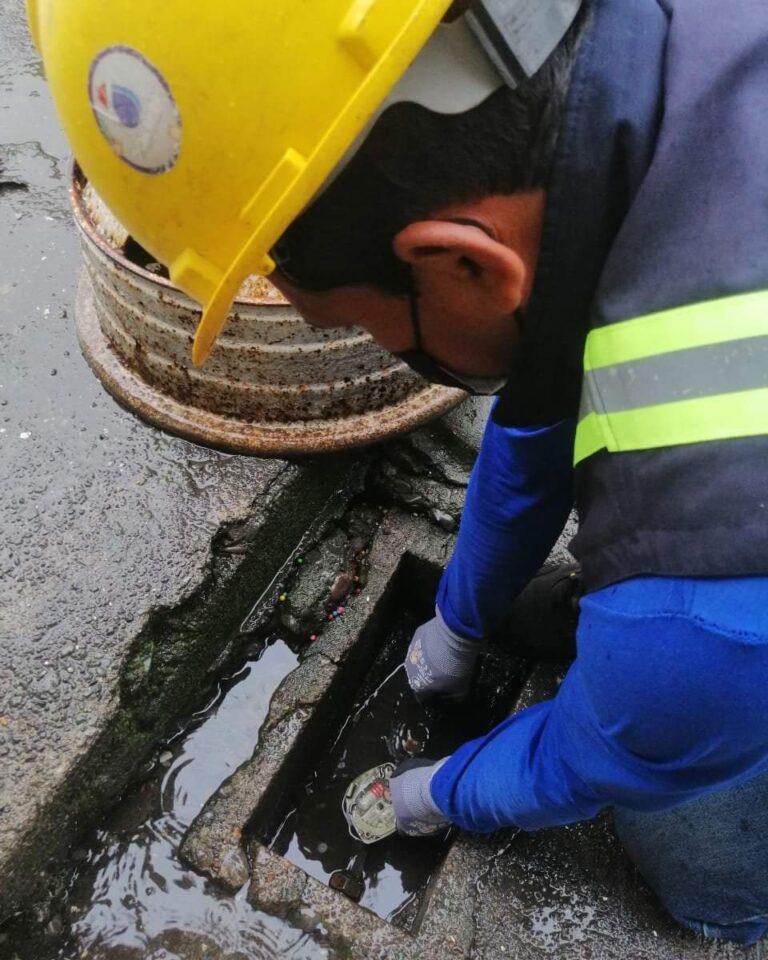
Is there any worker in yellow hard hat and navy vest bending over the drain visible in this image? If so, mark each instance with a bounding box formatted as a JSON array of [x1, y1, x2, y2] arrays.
[[29, 0, 768, 943]]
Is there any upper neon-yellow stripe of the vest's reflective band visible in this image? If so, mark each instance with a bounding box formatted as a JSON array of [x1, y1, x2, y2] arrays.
[[584, 290, 768, 370]]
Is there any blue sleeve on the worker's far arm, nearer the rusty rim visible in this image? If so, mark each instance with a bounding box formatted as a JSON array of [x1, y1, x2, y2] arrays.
[[437, 404, 575, 640]]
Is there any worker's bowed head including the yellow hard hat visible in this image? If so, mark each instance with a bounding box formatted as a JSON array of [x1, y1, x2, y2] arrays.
[[27, 0, 582, 376]]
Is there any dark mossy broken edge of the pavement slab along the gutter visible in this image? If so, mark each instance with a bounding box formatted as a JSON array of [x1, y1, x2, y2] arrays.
[[0, 457, 359, 919]]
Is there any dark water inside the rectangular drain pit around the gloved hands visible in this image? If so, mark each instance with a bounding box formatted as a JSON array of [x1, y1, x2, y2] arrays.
[[265, 615, 516, 929]]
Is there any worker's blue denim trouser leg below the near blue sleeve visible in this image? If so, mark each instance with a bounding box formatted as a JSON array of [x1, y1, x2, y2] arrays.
[[615, 774, 768, 944]]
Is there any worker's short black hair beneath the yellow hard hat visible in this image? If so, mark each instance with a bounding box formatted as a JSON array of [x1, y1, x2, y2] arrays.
[[275, 4, 587, 295]]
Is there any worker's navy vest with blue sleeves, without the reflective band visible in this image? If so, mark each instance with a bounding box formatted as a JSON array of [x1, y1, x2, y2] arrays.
[[432, 0, 768, 830]]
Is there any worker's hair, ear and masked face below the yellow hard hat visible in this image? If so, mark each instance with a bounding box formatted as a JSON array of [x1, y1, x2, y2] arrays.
[[271, 21, 581, 392]]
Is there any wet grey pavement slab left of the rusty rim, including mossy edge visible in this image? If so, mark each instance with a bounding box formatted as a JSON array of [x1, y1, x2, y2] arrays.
[[0, 0, 349, 921]]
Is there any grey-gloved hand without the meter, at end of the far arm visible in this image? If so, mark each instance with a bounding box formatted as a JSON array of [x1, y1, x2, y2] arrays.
[[405, 609, 482, 701]]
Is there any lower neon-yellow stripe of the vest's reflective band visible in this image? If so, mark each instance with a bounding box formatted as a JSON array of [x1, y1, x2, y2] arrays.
[[574, 387, 768, 463]]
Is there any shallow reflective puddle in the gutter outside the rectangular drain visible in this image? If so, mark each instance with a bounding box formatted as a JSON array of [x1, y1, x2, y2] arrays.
[[6, 640, 328, 960]]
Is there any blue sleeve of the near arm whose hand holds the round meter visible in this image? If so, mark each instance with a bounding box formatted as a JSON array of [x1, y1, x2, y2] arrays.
[[431, 577, 768, 832]]
